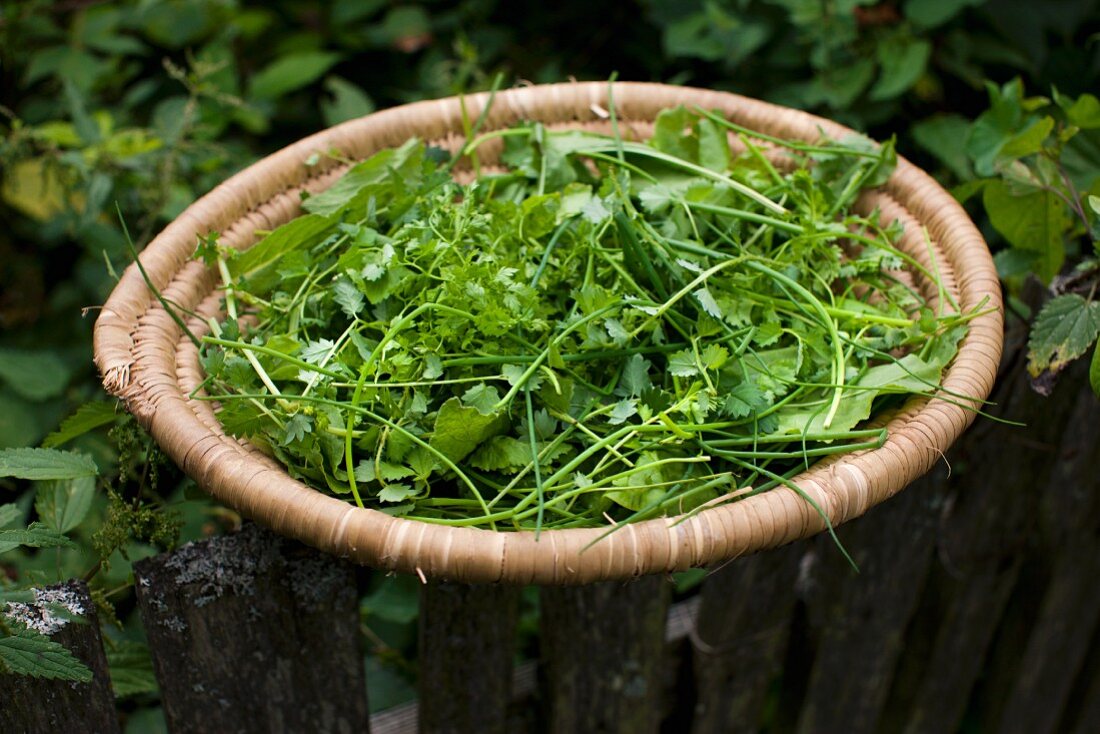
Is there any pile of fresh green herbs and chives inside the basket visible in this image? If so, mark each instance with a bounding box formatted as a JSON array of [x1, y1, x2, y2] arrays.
[[196, 108, 968, 529]]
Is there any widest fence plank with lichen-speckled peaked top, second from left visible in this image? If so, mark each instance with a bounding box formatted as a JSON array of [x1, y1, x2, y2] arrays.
[[134, 525, 370, 734]]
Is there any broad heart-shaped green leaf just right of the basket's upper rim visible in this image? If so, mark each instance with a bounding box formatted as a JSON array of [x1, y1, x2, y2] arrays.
[[982, 180, 1073, 283]]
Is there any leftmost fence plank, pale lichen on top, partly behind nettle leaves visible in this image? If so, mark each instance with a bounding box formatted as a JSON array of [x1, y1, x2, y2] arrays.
[[0, 580, 119, 734]]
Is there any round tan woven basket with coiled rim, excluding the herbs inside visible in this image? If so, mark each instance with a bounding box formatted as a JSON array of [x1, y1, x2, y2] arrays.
[[95, 83, 1002, 584]]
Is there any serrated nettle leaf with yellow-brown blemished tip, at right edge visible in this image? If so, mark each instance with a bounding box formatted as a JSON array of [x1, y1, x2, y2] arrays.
[[1027, 294, 1100, 376]]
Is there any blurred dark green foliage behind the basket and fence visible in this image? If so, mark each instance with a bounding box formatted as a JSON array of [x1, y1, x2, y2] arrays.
[[0, 0, 1100, 728]]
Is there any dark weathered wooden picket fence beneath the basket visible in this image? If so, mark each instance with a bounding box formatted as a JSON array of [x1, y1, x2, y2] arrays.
[[0, 341, 1100, 734]]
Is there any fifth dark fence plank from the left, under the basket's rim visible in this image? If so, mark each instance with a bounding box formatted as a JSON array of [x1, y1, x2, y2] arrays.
[[692, 543, 806, 734]]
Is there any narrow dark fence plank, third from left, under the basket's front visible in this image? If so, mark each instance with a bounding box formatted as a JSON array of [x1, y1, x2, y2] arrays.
[[418, 581, 519, 734]]
